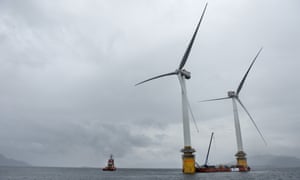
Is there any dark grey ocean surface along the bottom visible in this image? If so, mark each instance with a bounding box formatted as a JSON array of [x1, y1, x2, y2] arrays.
[[0, 167, 300, 180]]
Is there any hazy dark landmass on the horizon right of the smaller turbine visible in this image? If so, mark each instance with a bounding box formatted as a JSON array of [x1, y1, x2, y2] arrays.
[[247, 155, 300, 168]]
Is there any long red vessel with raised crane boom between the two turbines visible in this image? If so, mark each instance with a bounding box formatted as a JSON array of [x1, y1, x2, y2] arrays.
[[196, 132, 250, 173]]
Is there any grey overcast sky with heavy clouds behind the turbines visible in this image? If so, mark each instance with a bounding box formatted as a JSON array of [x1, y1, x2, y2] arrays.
[[0, 0, 300, 168]]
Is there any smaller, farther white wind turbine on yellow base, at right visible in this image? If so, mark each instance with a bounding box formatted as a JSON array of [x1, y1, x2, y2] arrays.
[[200, 48, 267, 168]]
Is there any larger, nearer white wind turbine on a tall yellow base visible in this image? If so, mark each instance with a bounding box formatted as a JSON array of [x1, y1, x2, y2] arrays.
[[136, 3, 207, 173]]
